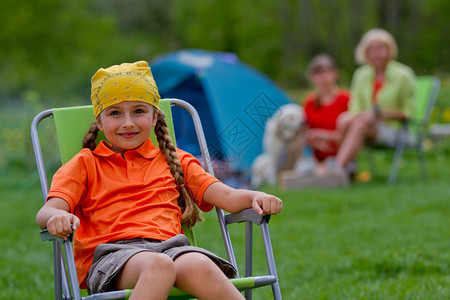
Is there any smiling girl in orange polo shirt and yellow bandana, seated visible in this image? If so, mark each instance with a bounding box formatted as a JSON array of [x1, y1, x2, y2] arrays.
[[36, 61, 282, 299]]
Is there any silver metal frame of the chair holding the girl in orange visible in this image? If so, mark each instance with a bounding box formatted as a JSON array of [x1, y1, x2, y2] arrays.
[[31, 99, 282, 300]]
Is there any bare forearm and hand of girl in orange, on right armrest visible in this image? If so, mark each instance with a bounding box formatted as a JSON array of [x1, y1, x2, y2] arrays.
[[203, 182, 283, 215]]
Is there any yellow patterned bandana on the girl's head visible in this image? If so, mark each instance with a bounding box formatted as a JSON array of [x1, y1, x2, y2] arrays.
[[91, 61, 161, 118]]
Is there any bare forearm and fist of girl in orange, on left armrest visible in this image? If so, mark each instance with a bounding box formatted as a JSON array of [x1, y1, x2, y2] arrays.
[[36, 198, 80, 240]]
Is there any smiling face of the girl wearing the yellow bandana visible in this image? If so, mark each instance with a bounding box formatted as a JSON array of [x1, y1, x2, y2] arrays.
[[97, 101, 158, 154]]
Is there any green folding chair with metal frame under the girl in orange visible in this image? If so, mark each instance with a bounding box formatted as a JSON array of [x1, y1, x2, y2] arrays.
[[31, 99, 281, 300]]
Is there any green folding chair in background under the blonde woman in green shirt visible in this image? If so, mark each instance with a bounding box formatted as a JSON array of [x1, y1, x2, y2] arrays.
[[369, 76, 441, 184]]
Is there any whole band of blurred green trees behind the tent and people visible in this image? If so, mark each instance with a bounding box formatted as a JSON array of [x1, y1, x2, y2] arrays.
[[0, 0, 450, 102]]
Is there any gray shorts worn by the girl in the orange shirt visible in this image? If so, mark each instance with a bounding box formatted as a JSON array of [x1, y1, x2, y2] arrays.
[[86, 234, 236, 293]]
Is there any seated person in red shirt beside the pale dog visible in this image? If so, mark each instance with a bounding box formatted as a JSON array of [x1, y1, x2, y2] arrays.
[[304, 54, 349, 174]]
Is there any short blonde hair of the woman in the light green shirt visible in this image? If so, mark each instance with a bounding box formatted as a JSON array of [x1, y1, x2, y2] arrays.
[[355, 28, 398, 64]]
